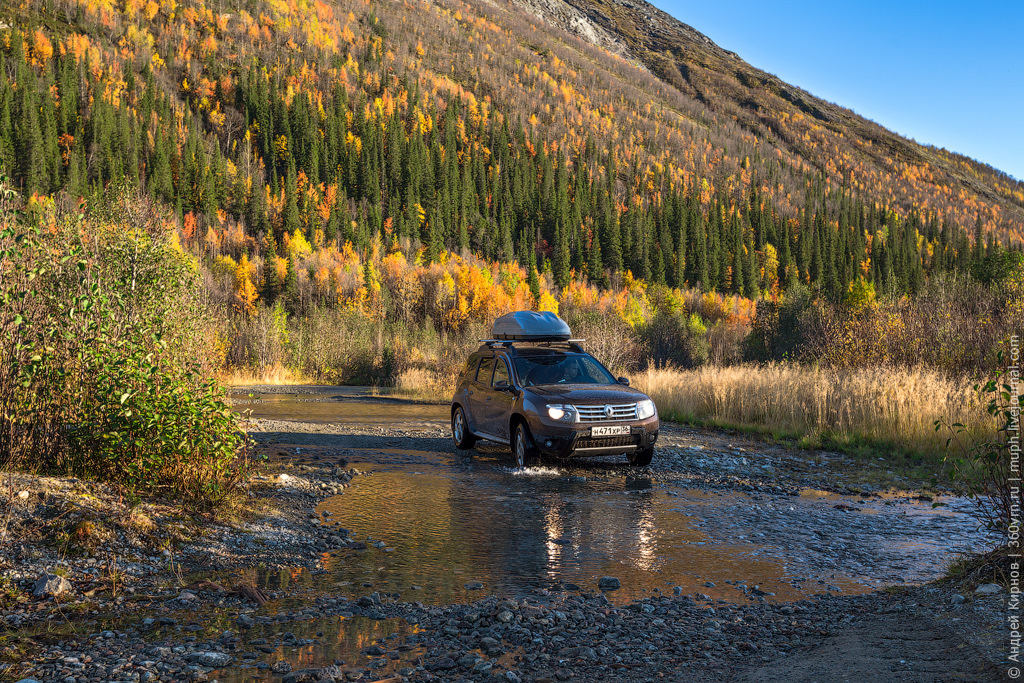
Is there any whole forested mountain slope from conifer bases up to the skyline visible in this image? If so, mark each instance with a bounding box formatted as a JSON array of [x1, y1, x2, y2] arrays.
[[0, 0, 1024, 313]]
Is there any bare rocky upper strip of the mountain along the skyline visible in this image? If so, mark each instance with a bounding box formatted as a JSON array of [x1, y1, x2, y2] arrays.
[[515, 0, 1024, 241]]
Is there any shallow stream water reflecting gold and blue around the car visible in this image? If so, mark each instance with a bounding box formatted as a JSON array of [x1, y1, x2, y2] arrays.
[[218, 388, 984, 681]]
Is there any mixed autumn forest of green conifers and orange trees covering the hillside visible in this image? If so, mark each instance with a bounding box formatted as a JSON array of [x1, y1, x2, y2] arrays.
[[0, 0, 1024, 389]]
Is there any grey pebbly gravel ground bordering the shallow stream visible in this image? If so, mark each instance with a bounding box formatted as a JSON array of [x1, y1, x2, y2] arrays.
[[0, 421, 1008, 683]]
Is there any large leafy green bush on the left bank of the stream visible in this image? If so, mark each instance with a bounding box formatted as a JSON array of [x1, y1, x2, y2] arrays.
[[0, 187, 247, 507]]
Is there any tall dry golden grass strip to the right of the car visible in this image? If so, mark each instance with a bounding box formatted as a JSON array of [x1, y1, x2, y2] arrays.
[[634, 365, 994, 455]]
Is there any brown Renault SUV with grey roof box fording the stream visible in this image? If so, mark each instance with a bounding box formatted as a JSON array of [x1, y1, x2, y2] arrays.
[[452, 311, 658, 467]]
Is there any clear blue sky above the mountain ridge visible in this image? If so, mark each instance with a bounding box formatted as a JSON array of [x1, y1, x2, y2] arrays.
[[653, 0, 1024, 180]]
